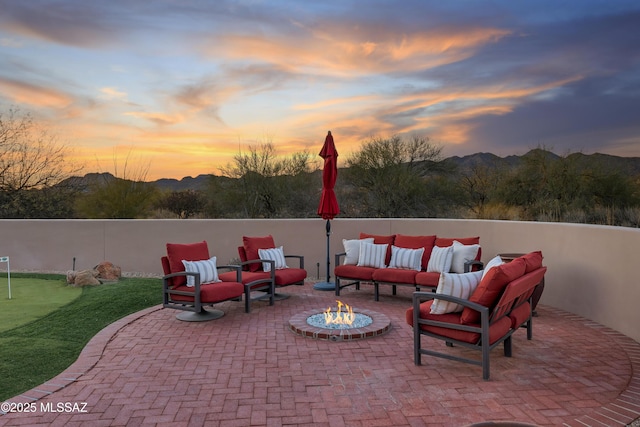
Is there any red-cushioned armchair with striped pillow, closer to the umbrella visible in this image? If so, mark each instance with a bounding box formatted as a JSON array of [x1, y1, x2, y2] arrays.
[[221, 235, 307, 300]]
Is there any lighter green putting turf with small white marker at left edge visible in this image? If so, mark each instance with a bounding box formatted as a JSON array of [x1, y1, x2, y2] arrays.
[[0, 274, 82, 332]]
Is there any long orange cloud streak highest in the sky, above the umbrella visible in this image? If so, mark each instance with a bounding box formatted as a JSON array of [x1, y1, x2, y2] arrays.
[[202, 23, 510, 75]]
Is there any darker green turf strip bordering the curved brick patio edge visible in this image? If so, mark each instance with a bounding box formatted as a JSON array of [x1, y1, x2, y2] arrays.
[[0, 278, 162, 401]]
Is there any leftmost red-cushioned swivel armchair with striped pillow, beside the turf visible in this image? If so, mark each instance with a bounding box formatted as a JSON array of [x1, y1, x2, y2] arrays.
[[161, 241, 272, 322]]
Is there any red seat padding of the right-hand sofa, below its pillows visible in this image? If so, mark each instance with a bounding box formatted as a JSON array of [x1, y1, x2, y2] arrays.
[[405, 300, 511, 344]]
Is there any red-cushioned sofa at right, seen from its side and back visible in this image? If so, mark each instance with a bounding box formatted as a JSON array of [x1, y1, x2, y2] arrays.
[[406, 251, 547, 380]]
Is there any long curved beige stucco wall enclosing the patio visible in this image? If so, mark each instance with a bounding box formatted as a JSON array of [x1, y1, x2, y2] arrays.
[[0, 219, 640, 342]]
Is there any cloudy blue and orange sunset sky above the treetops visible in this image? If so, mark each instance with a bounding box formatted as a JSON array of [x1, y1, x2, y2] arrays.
[[0, 0, 640, 180]]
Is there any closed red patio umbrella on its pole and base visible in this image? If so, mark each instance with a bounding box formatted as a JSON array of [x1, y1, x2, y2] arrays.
[[313, 131, 340, 291]]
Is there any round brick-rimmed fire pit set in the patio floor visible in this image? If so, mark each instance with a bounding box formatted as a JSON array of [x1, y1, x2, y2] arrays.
[[289, 308, 391, 341]]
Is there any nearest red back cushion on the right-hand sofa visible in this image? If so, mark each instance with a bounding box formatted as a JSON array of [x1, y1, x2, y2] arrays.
[[460, 258, 526, 324]]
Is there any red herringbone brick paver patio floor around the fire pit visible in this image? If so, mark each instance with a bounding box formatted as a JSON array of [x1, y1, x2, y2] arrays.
[[0, 284, 640, 427]]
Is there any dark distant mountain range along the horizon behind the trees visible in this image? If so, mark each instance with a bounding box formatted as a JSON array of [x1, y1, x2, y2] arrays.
[[66, 150, 640, 191]]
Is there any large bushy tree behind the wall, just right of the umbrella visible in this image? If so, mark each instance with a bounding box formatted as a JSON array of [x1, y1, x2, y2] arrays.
[[345, 135, 442, 218]]
